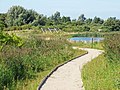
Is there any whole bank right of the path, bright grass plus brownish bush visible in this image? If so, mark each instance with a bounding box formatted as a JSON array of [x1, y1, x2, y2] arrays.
[[82, 34, 120, 90]]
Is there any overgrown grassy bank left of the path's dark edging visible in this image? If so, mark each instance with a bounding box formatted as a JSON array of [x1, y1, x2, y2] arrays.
[[0, 32, 85, 90]]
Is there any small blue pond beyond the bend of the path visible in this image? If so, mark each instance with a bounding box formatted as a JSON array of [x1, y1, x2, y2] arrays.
[[69, 37, 104, 42]]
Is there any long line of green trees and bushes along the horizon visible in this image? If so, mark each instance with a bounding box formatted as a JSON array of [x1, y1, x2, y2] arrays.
[[0, 6, 120, 31]]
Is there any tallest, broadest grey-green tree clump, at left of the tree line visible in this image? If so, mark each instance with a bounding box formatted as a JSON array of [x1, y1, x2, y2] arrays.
[[6, 6, 46, 27]]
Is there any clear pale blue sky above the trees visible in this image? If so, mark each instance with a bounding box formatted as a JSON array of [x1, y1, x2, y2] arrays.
[[0, 0, 120, 19]]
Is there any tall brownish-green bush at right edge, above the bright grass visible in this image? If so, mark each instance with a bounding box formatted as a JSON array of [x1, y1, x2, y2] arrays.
[[104, 34, 120, 63]]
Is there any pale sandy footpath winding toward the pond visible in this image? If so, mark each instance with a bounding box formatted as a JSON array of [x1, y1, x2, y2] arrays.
[[40, 48, 103, 90]]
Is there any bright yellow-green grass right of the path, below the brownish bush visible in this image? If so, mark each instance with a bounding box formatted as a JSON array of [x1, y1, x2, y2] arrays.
[[82, 55, 120, 90]]
